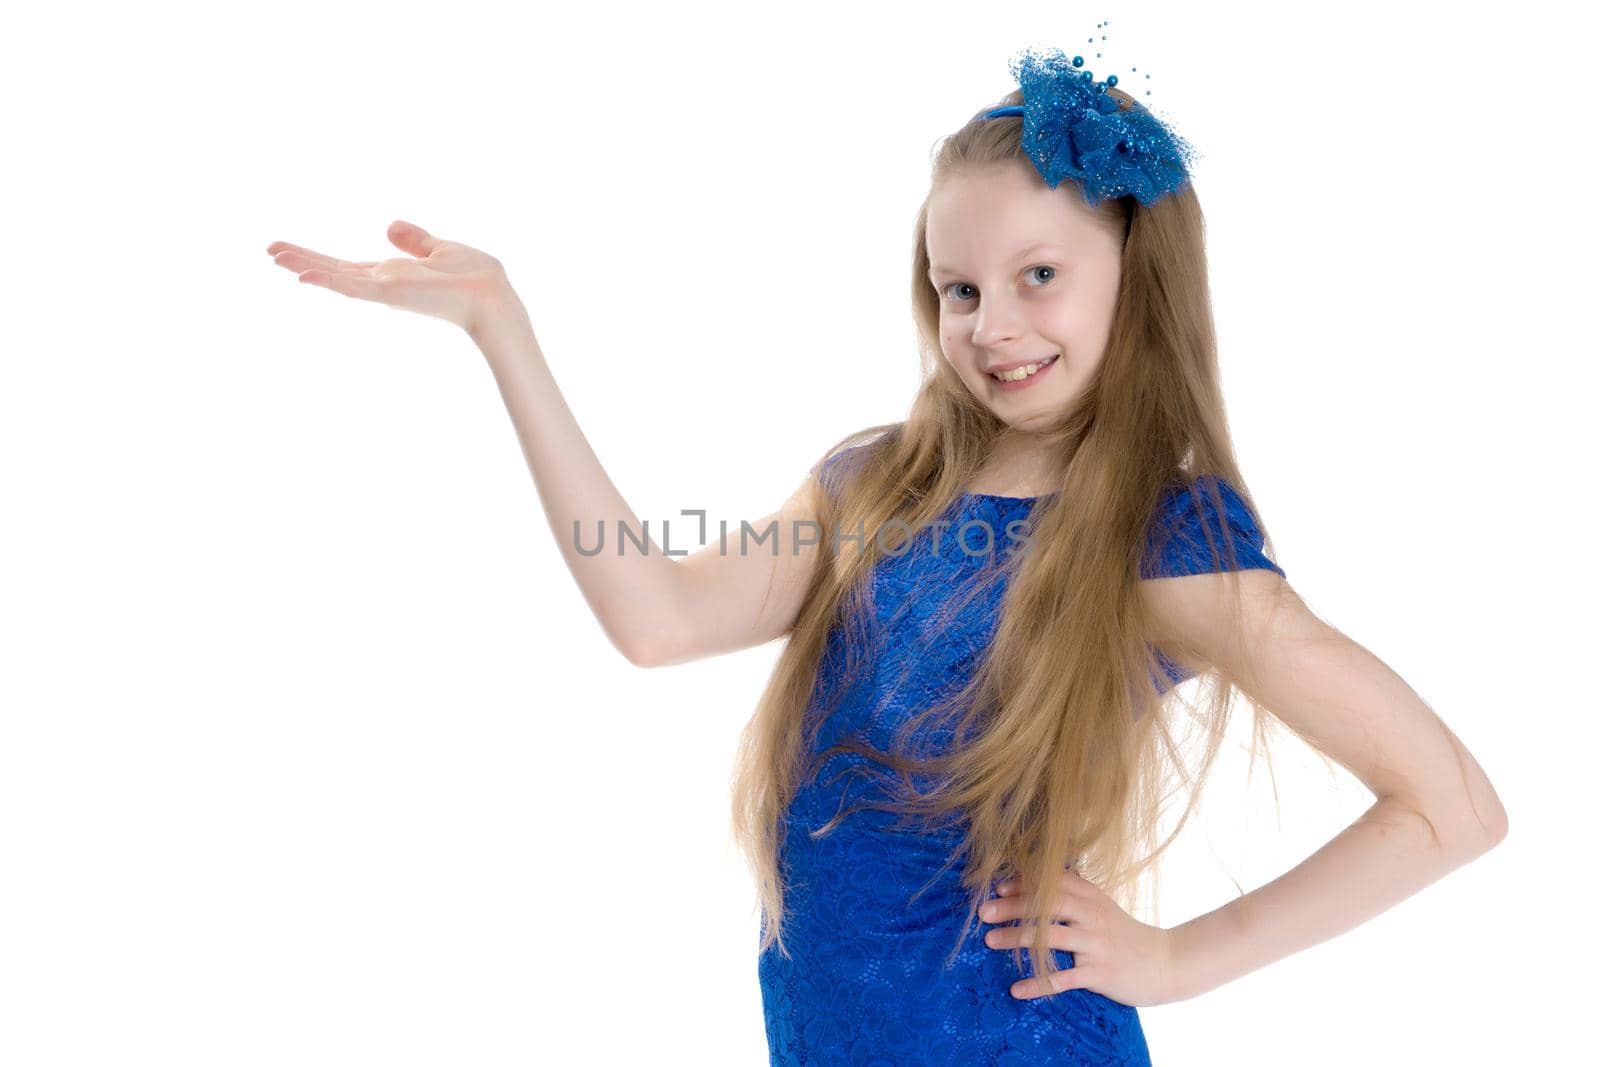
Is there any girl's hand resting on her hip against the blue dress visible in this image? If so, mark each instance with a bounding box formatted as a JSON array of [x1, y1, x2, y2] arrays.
[[978, 870, 1176, 1008]]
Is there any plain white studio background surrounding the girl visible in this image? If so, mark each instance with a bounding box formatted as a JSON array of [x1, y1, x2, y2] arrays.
[[0, 0, 1597, 1067]]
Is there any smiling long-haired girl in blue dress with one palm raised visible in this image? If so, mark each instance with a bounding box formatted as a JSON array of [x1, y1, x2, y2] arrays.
[[267, 41, 1506, 1067]]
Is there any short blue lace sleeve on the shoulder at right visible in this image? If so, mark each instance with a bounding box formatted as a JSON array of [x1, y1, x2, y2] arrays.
[[1139, 475, 1283, 577]]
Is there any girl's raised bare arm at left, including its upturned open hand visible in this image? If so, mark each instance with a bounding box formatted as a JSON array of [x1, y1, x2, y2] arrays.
[[267, 222, 819, 667]]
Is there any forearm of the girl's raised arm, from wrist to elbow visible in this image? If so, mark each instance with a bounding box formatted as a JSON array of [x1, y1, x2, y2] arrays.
[[469, 294, 683, 662]]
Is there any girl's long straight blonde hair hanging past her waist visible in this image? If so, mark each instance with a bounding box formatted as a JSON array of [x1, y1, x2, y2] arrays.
[[733, 88, 1292, 976]]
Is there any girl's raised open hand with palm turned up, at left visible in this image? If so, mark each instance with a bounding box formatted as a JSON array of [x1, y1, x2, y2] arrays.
[[267, 221, 517, 333]]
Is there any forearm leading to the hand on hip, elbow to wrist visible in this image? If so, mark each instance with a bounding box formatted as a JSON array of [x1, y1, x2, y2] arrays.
[[1171, 800, 1490, 1000]]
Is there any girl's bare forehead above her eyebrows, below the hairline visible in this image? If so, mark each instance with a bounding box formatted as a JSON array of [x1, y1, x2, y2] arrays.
[[925, 163, 1114, 270]]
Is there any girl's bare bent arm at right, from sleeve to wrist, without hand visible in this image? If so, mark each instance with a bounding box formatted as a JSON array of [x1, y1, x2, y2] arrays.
[[1142, 569, 1506, 1000]]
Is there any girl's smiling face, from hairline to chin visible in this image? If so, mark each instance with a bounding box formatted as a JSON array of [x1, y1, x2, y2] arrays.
[[926, 160, 1122, 432]]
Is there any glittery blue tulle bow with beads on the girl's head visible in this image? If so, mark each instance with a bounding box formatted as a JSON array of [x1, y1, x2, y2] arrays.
[[979, 48, 1197, 208]]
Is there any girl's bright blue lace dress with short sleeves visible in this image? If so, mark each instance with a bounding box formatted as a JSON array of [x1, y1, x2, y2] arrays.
[[758, 453, 1283, 1067]]
